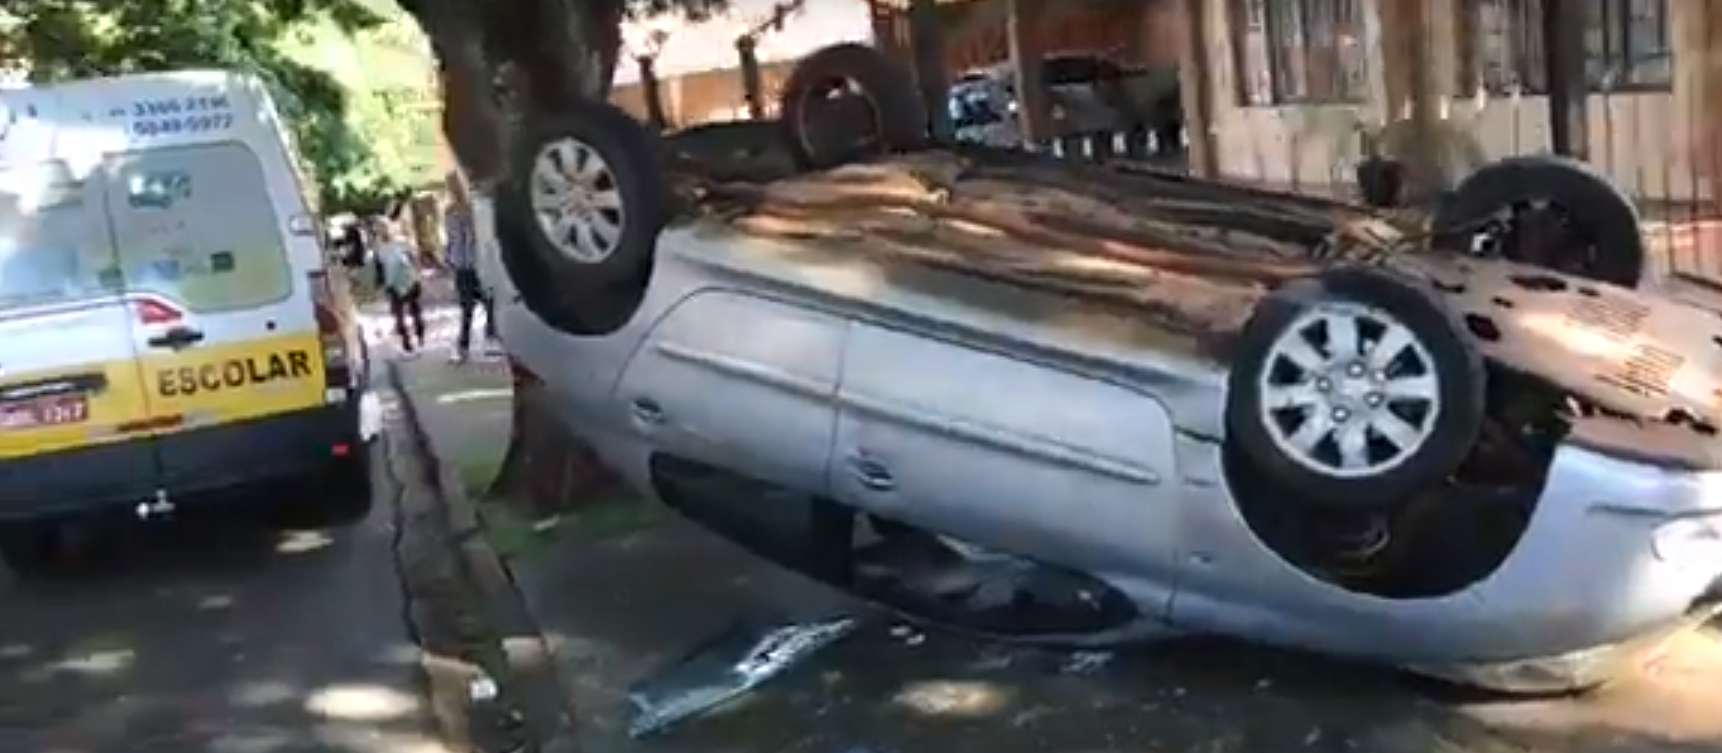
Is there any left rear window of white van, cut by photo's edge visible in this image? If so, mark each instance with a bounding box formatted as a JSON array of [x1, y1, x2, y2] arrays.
[[0, 162, 119, 310]]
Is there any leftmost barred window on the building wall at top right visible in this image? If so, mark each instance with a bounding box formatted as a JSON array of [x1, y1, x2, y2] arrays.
[[1228, 0, 1369, 105]]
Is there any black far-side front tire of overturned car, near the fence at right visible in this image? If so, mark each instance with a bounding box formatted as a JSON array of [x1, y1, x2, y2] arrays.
[[1433, 155, 1646, 288]]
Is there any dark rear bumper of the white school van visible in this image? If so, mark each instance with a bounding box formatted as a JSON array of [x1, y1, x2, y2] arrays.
[[0, 401, 365, 522]]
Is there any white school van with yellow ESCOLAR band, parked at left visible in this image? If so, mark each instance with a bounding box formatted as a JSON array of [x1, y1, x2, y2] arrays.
[[0, 71, 370, 567]]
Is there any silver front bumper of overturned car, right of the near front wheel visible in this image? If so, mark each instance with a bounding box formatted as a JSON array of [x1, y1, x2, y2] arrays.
[[1453, 434, 1722, 658]]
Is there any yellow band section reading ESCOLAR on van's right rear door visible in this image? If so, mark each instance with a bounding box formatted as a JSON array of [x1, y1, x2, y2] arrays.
[[139, 333, 325, 434]]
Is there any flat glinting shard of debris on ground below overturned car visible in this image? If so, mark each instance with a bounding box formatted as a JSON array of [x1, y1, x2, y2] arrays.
[[629, 617, 858, 739]]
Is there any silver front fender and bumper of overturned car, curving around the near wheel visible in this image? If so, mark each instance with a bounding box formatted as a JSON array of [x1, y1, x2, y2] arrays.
[[1168, 420, 1722, 665]]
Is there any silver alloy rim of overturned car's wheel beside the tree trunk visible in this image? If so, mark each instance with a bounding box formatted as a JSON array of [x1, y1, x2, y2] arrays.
[[530, 138, 627, 264]]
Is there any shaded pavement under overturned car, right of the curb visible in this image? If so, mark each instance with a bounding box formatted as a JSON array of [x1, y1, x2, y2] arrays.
[[515, 519, 1722, 753]]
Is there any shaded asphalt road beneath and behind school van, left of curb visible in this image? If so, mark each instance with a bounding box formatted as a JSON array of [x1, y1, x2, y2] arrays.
[[0, 461, 443, 753]]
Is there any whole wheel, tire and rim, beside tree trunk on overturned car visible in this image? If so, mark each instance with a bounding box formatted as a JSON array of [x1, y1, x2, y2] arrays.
[[496, 100, 672, 336]]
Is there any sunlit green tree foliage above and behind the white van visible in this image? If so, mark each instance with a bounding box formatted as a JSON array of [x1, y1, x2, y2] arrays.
[[0, 0, 434, 208]]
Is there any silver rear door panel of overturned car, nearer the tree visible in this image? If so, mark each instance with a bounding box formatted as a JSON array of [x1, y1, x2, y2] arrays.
[[616, 291, 847, 495]]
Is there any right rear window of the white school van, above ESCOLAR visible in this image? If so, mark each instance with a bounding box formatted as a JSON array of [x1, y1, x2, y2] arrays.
[[107, 143, 293, 312]]
